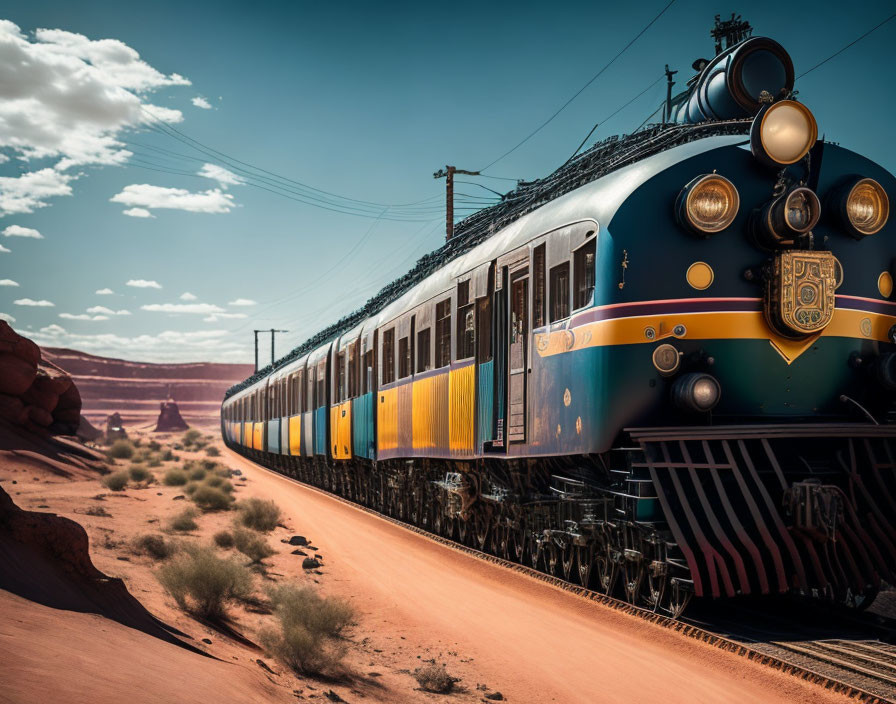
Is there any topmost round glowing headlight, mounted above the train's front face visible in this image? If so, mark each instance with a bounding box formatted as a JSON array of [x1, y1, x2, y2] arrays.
[[750, 100, 818, 166]]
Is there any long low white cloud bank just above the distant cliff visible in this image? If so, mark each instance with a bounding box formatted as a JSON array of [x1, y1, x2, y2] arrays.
[[30, 325, 251, 362]]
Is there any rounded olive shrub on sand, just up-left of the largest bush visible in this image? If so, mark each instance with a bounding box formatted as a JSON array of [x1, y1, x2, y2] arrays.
[[157, 548, 252, 619]]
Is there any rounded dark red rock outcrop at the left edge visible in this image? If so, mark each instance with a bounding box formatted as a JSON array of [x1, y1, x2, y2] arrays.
[[0, 320, 81, 434]]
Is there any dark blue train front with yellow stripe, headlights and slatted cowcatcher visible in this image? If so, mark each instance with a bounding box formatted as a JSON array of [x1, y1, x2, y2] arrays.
[[604, 30, 896, 606]]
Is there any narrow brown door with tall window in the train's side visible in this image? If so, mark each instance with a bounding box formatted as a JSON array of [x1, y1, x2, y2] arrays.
[[507, 262, 529, 442]]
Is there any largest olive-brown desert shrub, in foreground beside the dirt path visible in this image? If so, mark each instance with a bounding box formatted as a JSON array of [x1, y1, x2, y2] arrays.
[[259, 585, 354, 674]]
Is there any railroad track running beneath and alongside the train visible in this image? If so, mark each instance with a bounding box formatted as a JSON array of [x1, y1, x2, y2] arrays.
[[238, 450, 896, 704]]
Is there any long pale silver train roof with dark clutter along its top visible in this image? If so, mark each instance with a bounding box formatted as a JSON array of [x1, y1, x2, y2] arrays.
[[225, 120, 751, 399]]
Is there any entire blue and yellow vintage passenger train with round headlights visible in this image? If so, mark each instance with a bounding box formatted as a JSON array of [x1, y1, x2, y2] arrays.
[[221, 18, 896, 617]]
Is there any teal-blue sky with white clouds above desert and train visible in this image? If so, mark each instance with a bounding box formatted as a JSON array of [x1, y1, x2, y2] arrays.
[[0, 0, 896, 361]]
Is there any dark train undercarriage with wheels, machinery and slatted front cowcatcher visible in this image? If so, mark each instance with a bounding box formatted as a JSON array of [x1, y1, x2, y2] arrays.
[[232, 425, 896, 617]]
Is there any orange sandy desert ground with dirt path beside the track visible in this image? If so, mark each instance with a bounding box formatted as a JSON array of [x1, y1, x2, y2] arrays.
[[0, 418, 860, 703]]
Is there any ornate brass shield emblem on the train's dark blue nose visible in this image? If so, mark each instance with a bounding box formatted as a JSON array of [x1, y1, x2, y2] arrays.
[[765, 250, 837, 338]]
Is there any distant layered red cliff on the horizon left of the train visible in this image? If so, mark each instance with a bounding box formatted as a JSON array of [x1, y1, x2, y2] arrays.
[[42, 347, 253, 425]]
